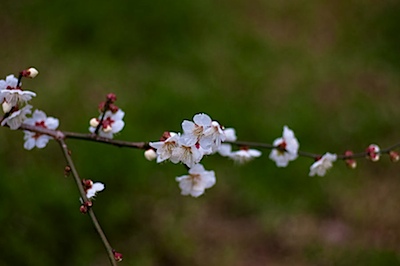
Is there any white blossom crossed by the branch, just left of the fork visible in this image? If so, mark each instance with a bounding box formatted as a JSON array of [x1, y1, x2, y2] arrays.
[[24, 110, 59, 150]]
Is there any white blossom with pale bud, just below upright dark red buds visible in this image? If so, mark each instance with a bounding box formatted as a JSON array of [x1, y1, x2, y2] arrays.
[[89, 109, 125, 139]]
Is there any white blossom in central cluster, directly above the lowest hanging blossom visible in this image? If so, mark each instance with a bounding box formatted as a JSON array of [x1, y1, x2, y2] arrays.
[[169, 138, 204, 168]]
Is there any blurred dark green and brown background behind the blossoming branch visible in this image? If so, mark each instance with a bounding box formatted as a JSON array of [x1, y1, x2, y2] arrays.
[[0, 0, 400, 266]]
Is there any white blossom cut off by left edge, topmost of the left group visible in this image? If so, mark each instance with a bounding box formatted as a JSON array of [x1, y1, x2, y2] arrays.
[[0, 75, 36, 106]]
